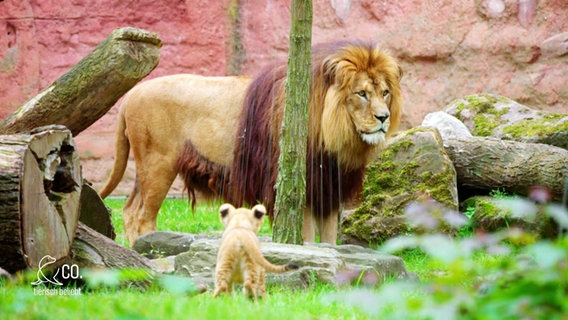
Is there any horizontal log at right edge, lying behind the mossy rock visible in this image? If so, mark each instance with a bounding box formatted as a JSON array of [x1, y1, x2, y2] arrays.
[[444, 137, 568, 201]]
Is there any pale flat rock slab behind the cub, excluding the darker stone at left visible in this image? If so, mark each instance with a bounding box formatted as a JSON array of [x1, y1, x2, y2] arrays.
[[171, 239, 410, 289]]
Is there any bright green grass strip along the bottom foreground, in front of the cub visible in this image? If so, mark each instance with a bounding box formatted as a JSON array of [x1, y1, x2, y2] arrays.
[[0, 286, 367, 319]]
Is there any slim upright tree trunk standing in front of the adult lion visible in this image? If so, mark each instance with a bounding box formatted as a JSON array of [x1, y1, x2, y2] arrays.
[[273, 0, 312, 244]]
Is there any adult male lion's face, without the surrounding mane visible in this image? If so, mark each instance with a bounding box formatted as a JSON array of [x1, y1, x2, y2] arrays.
[[345, 72, 391, 144]]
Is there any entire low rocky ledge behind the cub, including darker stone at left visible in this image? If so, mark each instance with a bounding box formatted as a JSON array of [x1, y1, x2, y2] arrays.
[[133, 231, 415, 289]]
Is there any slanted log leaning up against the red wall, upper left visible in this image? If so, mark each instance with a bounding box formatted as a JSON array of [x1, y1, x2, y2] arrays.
[[0, 28, 161, 136]]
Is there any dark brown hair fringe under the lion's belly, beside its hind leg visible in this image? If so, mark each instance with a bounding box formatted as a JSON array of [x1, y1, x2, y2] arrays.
[[175, 141, 230, 212]]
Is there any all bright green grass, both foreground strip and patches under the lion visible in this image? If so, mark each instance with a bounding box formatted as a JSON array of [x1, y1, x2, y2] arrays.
[[0, 199, 368, 319]]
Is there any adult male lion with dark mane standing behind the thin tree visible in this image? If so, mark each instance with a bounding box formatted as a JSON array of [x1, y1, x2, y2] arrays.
[[101, 42, 402, 243]]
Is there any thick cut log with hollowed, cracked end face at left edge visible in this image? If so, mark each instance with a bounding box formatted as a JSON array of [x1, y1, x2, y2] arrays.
[[0, 125, 82, 273]]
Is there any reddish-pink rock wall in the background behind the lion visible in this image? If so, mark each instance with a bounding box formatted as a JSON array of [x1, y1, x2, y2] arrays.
[[0, 0, 568, 194]]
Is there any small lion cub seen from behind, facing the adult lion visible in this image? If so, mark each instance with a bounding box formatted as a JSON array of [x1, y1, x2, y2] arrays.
[[213, 203, 298, 299]]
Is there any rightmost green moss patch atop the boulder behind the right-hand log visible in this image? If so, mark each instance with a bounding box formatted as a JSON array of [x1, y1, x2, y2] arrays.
[[503, 113, 568, 138]]
